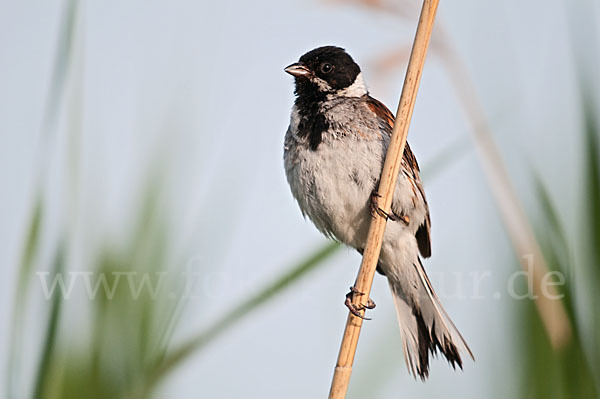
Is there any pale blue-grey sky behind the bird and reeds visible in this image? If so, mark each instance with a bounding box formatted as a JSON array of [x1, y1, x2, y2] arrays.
[[0, 0, 598, 399]]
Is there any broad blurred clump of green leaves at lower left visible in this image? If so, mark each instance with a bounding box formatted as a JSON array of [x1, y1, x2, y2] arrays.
[[36, 181, 181, 399]]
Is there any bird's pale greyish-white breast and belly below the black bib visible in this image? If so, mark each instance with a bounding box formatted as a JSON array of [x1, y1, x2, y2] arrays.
[[284, 104, 422, 252]]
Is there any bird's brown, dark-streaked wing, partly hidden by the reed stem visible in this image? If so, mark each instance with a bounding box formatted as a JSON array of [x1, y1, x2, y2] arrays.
[[367, 96, 431, 258]]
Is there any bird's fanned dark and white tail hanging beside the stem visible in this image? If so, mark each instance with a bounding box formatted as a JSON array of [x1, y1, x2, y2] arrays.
[[388, 260, 474, 380]]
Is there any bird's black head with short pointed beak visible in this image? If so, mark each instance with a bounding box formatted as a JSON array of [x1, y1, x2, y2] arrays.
[[285, 46, 366, 96]]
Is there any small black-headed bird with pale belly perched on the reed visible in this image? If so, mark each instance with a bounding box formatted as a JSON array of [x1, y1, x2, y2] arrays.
[[283, 46, 474, 381]]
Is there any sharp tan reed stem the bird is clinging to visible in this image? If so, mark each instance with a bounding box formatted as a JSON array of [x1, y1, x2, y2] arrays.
[[329, 0, 439, 399]]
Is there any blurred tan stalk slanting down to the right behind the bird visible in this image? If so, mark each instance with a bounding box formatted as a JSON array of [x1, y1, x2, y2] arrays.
[[361, 0, 573, 350]]
